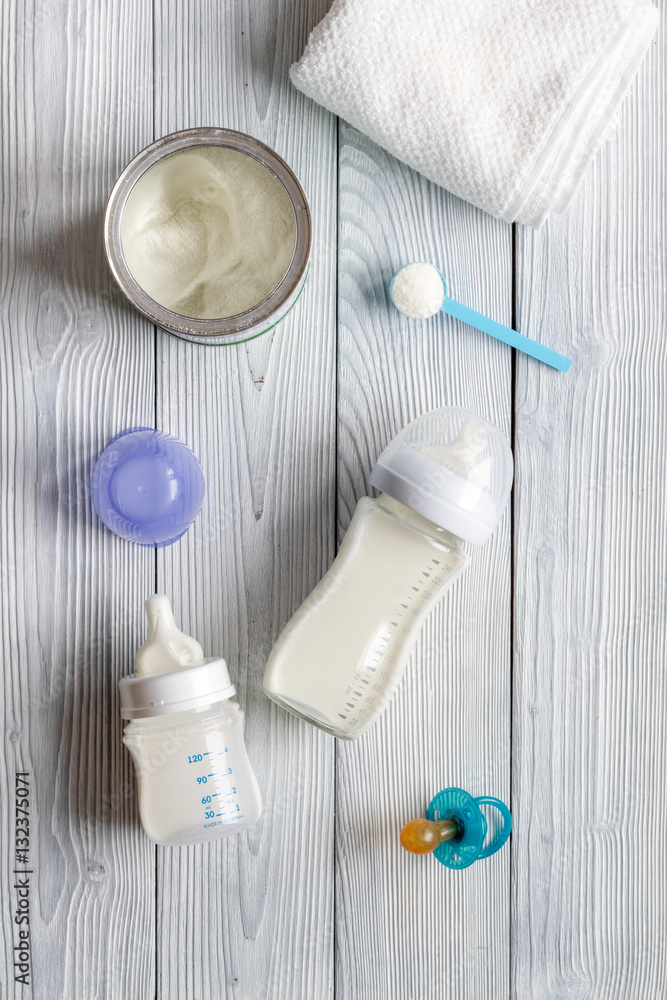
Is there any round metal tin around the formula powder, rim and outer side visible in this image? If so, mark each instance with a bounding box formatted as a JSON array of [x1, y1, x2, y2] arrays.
[[104, 128, 312, 344]]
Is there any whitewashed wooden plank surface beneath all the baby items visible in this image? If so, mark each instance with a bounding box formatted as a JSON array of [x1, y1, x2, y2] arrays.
[[0, 0, 667, 1000]]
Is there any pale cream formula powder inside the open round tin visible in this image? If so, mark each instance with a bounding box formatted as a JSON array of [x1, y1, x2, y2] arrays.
[[121, 146, 296, 319]]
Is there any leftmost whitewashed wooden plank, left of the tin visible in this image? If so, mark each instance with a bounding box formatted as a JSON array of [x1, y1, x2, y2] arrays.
[[0, 0, 155, 1000]]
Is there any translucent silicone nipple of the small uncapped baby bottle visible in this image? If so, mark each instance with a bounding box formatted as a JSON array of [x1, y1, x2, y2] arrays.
[[134, 594, 204, 677]]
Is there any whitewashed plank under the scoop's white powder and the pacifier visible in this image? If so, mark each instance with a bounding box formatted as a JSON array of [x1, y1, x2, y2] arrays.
[[336, 124, 512, 1000]]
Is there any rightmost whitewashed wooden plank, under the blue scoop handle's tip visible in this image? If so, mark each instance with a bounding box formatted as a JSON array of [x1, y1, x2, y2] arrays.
[[512, 4, 667, 1000]]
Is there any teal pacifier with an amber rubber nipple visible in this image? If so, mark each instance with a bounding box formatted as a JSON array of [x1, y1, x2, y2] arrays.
[[401, 788, 512, 868]]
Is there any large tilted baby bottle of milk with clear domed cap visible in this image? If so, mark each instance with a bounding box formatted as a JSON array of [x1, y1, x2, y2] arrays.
[[264, 407, 512, 739]]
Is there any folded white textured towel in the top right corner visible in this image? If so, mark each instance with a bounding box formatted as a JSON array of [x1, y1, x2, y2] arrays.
[[291, 0, 659, 226]]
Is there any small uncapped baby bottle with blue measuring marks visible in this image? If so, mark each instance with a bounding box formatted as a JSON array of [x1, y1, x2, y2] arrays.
[[120, 594, 262, 847]]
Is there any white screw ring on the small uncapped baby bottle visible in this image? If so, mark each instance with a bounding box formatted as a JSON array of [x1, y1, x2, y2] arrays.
[[120, 657, 236, 719]]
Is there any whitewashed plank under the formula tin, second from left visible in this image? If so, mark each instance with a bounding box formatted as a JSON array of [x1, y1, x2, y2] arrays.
[[156, 0, 336, 1000]]
